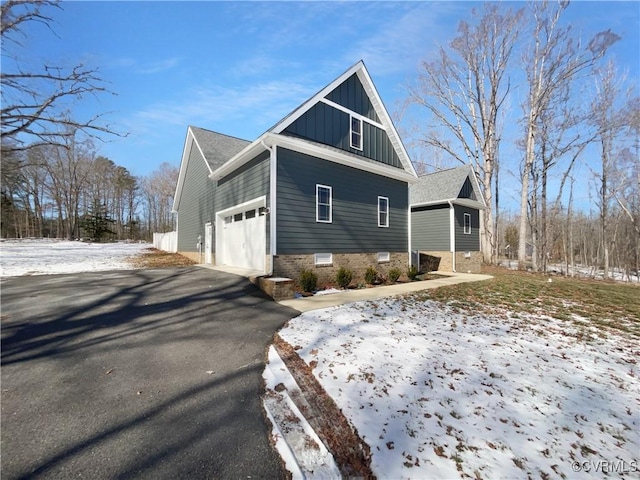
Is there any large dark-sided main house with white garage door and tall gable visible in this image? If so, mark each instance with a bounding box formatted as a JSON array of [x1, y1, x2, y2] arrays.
[[174, 61, 417, 284]]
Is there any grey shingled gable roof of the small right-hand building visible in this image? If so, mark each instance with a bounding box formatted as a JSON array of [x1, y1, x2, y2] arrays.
[[409, 165, 486, 209]]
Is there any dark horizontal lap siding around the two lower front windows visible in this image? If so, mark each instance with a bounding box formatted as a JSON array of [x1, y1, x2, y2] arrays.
[[276, 148, 409, 255]]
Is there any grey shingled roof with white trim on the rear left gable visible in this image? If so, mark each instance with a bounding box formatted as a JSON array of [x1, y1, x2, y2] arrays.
[[172, 125, 251, 213]]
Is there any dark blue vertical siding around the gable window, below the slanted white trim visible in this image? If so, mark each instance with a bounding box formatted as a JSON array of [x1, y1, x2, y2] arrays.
[[283, 102, 403, 168]]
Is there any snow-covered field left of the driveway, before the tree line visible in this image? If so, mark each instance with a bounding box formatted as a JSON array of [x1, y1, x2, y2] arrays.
[[0, 240, 152, 277]]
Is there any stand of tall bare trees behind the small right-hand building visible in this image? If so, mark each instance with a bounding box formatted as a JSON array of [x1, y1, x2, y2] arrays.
[[404, 0, 640, 277]]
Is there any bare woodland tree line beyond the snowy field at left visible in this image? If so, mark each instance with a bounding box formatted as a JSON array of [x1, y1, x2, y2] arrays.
[[0, 132, 178, 240]]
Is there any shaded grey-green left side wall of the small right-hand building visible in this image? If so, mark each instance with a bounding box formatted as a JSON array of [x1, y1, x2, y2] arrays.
[[411, 205, 451, 252]]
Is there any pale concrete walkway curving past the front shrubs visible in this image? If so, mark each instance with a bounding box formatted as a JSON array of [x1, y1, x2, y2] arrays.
[[279, 272, 493, 312]]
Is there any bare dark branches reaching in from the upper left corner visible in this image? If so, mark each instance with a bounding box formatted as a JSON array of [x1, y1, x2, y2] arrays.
[[0, 0, 122, 153]]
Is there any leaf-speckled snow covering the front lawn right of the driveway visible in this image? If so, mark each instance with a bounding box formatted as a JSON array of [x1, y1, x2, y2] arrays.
[[280, 297, 640, 479]]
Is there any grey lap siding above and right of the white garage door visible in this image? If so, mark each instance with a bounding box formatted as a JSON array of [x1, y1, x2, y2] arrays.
[[213, 152, 270, 253]]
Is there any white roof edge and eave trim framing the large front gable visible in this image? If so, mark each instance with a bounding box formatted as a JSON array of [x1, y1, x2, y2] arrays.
[[211, 60, 417, 182]]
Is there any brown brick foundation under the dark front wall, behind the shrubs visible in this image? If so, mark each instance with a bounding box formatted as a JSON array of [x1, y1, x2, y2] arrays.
[[273, 252, 409, 288]]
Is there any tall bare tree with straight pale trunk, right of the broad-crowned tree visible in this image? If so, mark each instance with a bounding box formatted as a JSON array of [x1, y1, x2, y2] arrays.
[[518, 0, 620, 269]]
